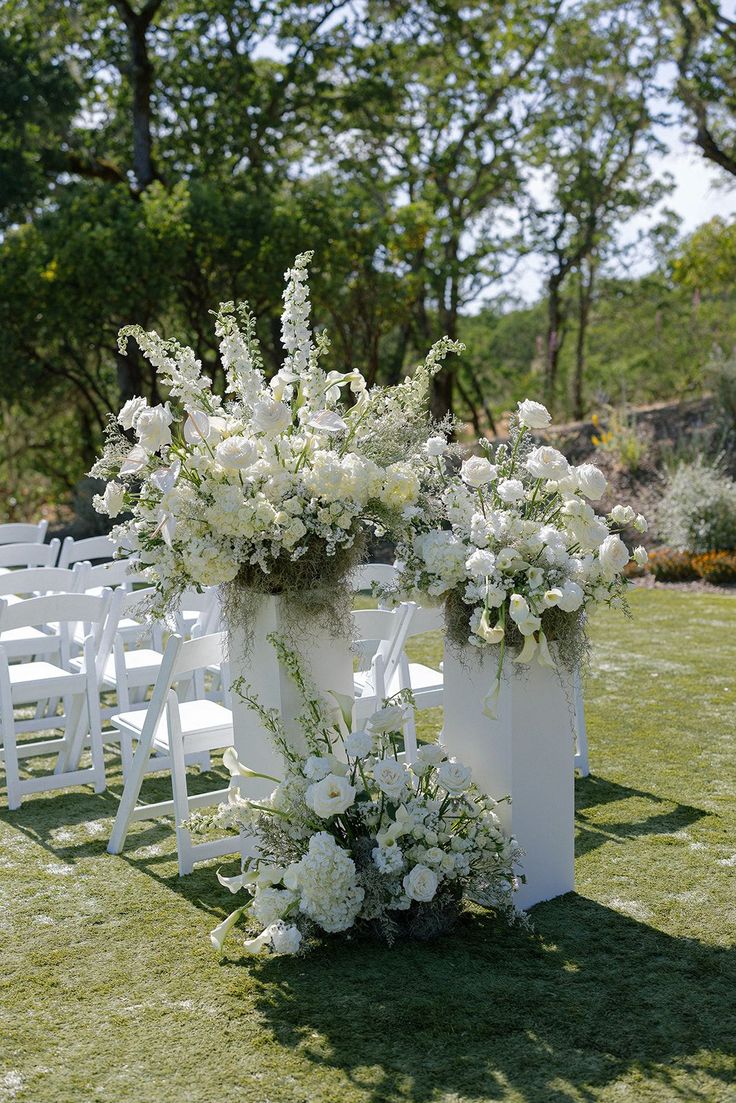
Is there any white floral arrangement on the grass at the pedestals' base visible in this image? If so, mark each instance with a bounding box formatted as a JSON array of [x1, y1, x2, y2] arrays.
[[201, 635, 525, 954]]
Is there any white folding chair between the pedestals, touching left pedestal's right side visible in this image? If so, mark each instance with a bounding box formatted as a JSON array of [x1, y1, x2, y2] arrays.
[[353, 601, 417, 762]]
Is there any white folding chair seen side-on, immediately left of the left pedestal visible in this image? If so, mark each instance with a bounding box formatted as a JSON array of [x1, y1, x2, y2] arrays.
[[107, 632, 241, 877]]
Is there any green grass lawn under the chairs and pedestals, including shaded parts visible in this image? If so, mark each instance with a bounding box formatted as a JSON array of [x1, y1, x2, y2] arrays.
[[0, 591, 736, 1103]]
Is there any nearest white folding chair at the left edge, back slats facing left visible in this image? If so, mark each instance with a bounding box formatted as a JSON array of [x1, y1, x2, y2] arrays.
[[0, 591, 110, 810]]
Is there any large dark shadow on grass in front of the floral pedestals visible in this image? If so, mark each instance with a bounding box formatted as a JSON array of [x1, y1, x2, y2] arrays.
[[241, 893, 736, 1103]]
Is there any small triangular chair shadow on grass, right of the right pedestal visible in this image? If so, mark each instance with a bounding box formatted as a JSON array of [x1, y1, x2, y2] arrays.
[[575, 774, 707, 857]]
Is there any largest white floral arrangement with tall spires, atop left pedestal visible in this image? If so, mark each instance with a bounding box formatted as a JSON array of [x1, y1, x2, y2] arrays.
[[92, 253, 461, 613]]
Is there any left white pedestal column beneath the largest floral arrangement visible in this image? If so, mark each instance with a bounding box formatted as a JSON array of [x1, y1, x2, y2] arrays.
[[230, 597, 353, 796]]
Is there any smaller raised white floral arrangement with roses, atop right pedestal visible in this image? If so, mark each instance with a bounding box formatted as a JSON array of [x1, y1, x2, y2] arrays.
[[395, 399, 647, 697]]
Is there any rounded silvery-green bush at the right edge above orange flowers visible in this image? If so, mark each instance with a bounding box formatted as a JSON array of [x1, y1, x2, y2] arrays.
[[658, 457, 736, 553]]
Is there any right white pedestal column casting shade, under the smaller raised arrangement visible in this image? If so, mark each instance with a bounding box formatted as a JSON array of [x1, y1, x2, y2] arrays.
[[444, 647, 575, 908]]
